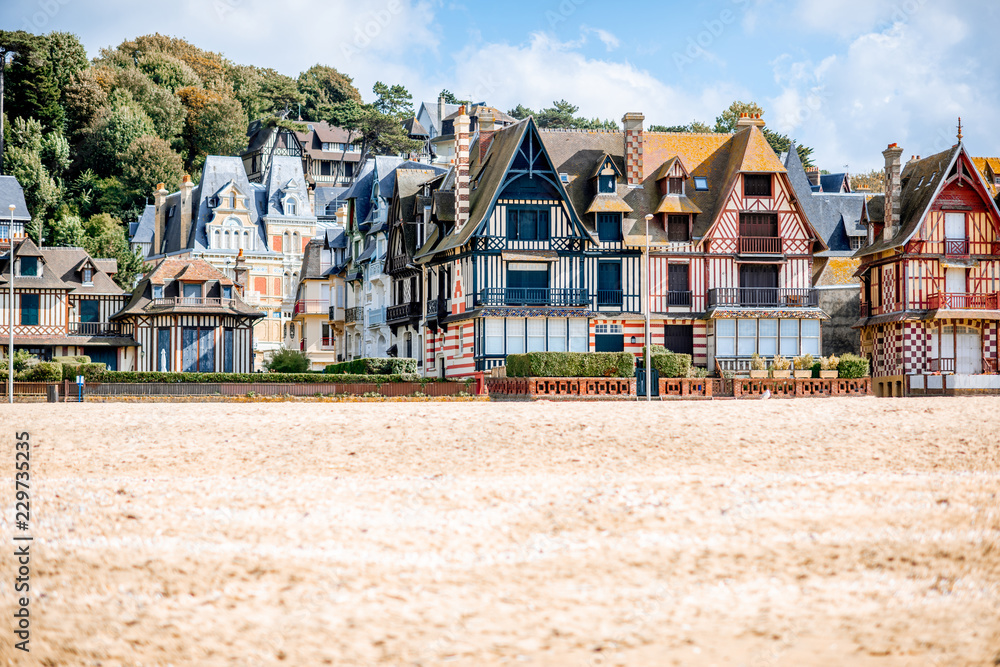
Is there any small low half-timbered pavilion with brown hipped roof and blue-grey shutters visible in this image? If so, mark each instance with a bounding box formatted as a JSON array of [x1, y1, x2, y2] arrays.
[[111, 257, 264, 373]]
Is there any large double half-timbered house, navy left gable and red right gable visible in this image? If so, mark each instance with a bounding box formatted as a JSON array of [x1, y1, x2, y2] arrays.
[[416, 109, 826, 376]]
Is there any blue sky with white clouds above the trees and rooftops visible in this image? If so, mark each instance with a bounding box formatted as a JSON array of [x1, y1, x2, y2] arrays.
[[0, 0, 1000, 173]]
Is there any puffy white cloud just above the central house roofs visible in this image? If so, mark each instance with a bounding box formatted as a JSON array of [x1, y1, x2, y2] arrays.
[[452, 32, 746, 125]]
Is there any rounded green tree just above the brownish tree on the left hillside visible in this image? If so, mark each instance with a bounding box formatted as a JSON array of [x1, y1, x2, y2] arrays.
[[80, 101, 156, 176]]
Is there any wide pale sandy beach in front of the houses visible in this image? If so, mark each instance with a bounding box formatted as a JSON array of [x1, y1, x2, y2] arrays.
[[0, 397, 1000, 667]]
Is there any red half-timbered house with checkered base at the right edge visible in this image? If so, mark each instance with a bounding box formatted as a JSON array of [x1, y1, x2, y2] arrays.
[[857, 134, 1000, 396]]
